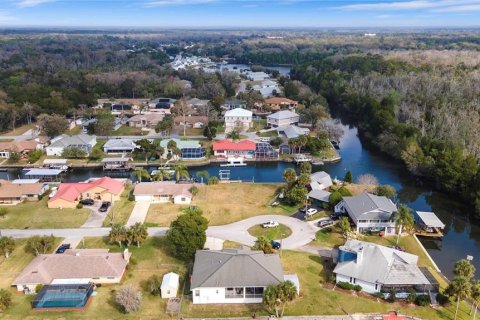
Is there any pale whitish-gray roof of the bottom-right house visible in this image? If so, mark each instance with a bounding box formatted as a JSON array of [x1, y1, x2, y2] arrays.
[[333, 240, 430, 285]]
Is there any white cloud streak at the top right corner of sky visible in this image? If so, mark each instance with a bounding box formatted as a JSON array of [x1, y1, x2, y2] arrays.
[[336, 0, 480, 11]]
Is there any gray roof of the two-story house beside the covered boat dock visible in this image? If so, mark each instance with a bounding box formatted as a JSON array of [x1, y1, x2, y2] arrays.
[[343, 193, 397, 220]]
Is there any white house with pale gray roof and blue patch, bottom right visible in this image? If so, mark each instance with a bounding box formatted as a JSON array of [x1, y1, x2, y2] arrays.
[[333, 239, 435, 293]]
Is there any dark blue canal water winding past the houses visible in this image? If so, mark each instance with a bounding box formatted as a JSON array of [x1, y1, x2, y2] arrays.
[[0, 127, 480, 277]]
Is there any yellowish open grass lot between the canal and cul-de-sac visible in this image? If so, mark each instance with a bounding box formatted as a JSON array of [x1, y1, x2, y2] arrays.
[[146, 183, 297, 226]]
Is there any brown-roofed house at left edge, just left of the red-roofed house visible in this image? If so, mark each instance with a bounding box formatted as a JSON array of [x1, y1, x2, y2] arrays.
[[0, 179, 48, 205]]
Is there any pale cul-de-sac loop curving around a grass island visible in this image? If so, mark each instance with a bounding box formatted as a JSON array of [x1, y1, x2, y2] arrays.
[[207, 215, 318, 249]]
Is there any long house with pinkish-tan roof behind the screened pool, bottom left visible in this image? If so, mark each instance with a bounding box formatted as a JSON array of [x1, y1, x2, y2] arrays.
[[12, 249, 131, 293]]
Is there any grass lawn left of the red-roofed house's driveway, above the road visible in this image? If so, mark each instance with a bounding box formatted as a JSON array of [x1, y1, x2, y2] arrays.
[[0, 197, 90, 229]]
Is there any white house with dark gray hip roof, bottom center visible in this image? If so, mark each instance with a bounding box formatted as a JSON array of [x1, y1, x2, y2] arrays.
[[190, 248, 299, 304]]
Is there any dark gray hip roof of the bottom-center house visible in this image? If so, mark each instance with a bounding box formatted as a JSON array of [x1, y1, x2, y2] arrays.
[[191, 249, 283, 290]]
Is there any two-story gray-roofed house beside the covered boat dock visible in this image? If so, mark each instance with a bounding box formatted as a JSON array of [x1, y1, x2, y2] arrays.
[[335, 192, 397, 235]]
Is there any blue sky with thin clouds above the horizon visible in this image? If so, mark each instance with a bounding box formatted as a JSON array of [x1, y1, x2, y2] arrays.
[[0, 0, 480, 28]]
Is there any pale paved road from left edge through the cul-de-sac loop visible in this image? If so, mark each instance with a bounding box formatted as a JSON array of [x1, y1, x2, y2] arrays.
[[1, 215, 318, 249]]
